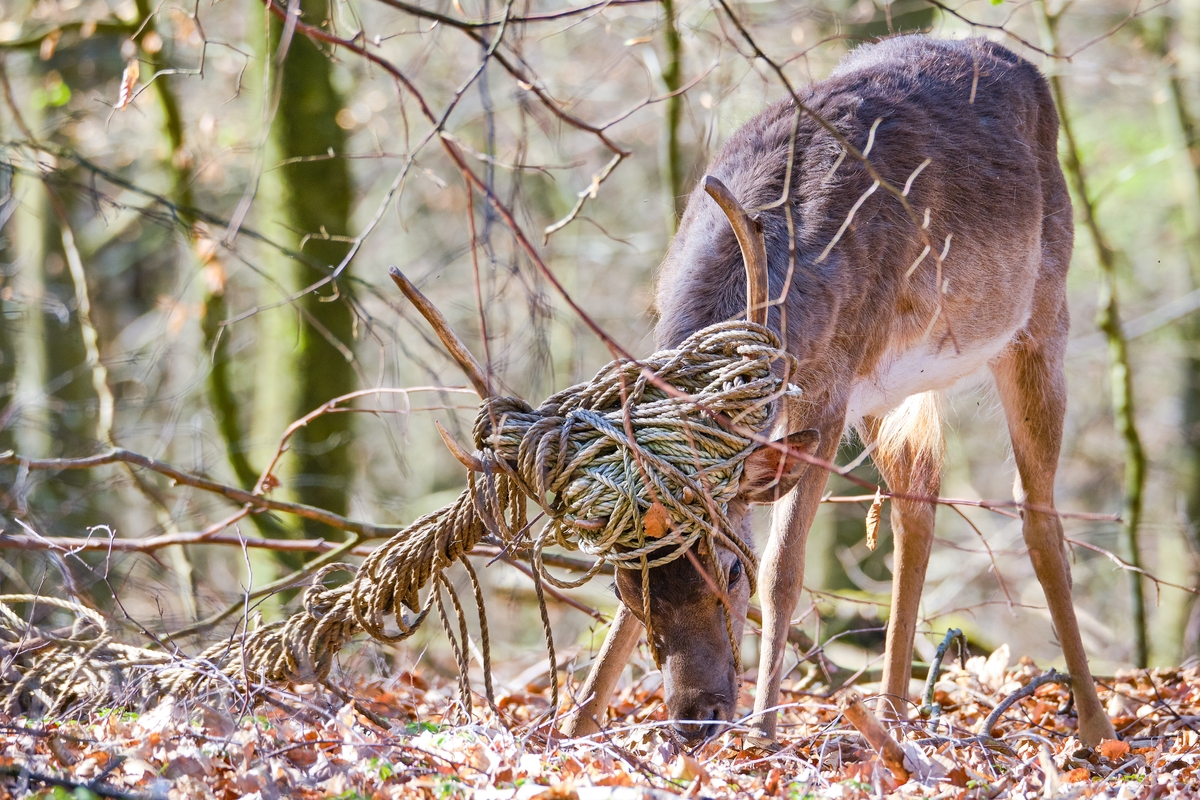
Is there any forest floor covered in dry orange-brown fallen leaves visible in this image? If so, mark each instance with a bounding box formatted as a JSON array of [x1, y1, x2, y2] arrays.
[[0, 648, 1200, 800]]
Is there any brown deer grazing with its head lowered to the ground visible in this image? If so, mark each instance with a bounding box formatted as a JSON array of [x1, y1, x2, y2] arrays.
[[568, 36, 1115, 745]]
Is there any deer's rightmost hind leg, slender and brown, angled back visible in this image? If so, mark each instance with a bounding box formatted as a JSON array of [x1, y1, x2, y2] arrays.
[[991, 321, 1116, 745]]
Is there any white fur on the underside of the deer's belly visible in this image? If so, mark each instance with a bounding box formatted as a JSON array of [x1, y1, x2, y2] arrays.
[[846, 330, 1016, 423]]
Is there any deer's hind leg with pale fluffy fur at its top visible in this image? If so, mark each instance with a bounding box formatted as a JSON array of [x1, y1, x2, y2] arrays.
[[862, 392, 943, 720]]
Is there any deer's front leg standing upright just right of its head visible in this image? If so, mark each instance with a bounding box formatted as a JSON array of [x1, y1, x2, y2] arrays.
[[751, 424, 845, 739]]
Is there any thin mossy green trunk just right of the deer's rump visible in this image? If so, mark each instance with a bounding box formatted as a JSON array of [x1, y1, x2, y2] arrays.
[[1042, 4, 1150, 667]]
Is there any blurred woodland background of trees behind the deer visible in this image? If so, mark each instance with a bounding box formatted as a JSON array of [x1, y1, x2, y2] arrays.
[[0, 0, 1200, 700]]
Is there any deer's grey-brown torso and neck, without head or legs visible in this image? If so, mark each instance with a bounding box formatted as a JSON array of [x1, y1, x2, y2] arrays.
[[655, 36, 1072, 424]]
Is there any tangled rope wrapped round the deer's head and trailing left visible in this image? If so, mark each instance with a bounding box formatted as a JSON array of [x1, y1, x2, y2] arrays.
[[0, 321, 792, 712]]
